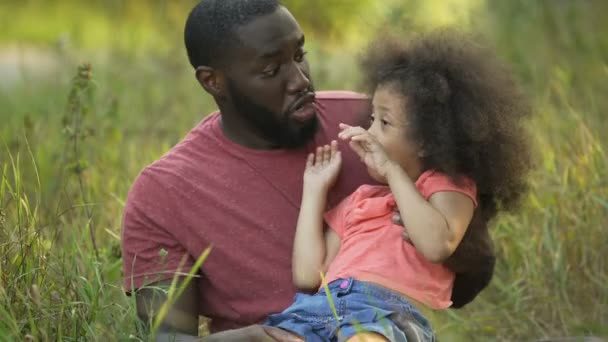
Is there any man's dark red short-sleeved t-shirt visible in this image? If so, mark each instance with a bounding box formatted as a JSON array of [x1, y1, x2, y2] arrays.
[[122, 92, 372, 331]]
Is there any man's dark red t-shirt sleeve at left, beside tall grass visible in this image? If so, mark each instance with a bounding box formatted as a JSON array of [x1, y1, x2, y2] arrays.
[[122, 170, 194, 292]]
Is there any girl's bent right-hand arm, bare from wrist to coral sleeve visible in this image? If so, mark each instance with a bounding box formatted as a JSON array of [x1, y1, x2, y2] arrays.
[[386, 164, 475, 263]]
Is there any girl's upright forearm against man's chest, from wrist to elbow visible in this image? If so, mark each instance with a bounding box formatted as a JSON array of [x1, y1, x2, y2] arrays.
[[292, 187, 327, 289]]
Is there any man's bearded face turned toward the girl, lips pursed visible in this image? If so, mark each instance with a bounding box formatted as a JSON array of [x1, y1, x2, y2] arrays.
[[222, 7, 318, 147]]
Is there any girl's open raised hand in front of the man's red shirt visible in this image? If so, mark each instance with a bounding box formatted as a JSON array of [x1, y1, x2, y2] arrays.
[[304, 140, 342, 191]]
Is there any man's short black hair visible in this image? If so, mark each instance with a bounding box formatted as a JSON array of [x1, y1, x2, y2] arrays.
[[184, 0, 280, 68]]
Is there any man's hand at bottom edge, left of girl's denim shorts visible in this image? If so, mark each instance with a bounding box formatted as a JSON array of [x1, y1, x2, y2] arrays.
[[202, 325, 304, 342]]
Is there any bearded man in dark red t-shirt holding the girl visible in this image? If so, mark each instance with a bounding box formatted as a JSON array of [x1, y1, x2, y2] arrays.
[[122, 0, 494, 341]]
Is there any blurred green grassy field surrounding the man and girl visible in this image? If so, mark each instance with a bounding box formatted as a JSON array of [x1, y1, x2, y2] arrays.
[[0, 0, 608, 341]]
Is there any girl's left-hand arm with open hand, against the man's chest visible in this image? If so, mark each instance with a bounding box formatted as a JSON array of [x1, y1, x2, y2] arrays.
[[292, 141, 342, 289]]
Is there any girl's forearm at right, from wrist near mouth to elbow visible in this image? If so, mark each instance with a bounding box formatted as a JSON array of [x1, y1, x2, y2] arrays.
[[386, 164, 452, 263]]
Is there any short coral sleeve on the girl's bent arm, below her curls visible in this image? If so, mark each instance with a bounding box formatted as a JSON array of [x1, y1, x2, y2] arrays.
[[416, 171, 477, 208]]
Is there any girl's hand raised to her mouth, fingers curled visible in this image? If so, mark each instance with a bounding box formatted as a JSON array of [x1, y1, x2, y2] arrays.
[[338, 123, 394, 179]]
